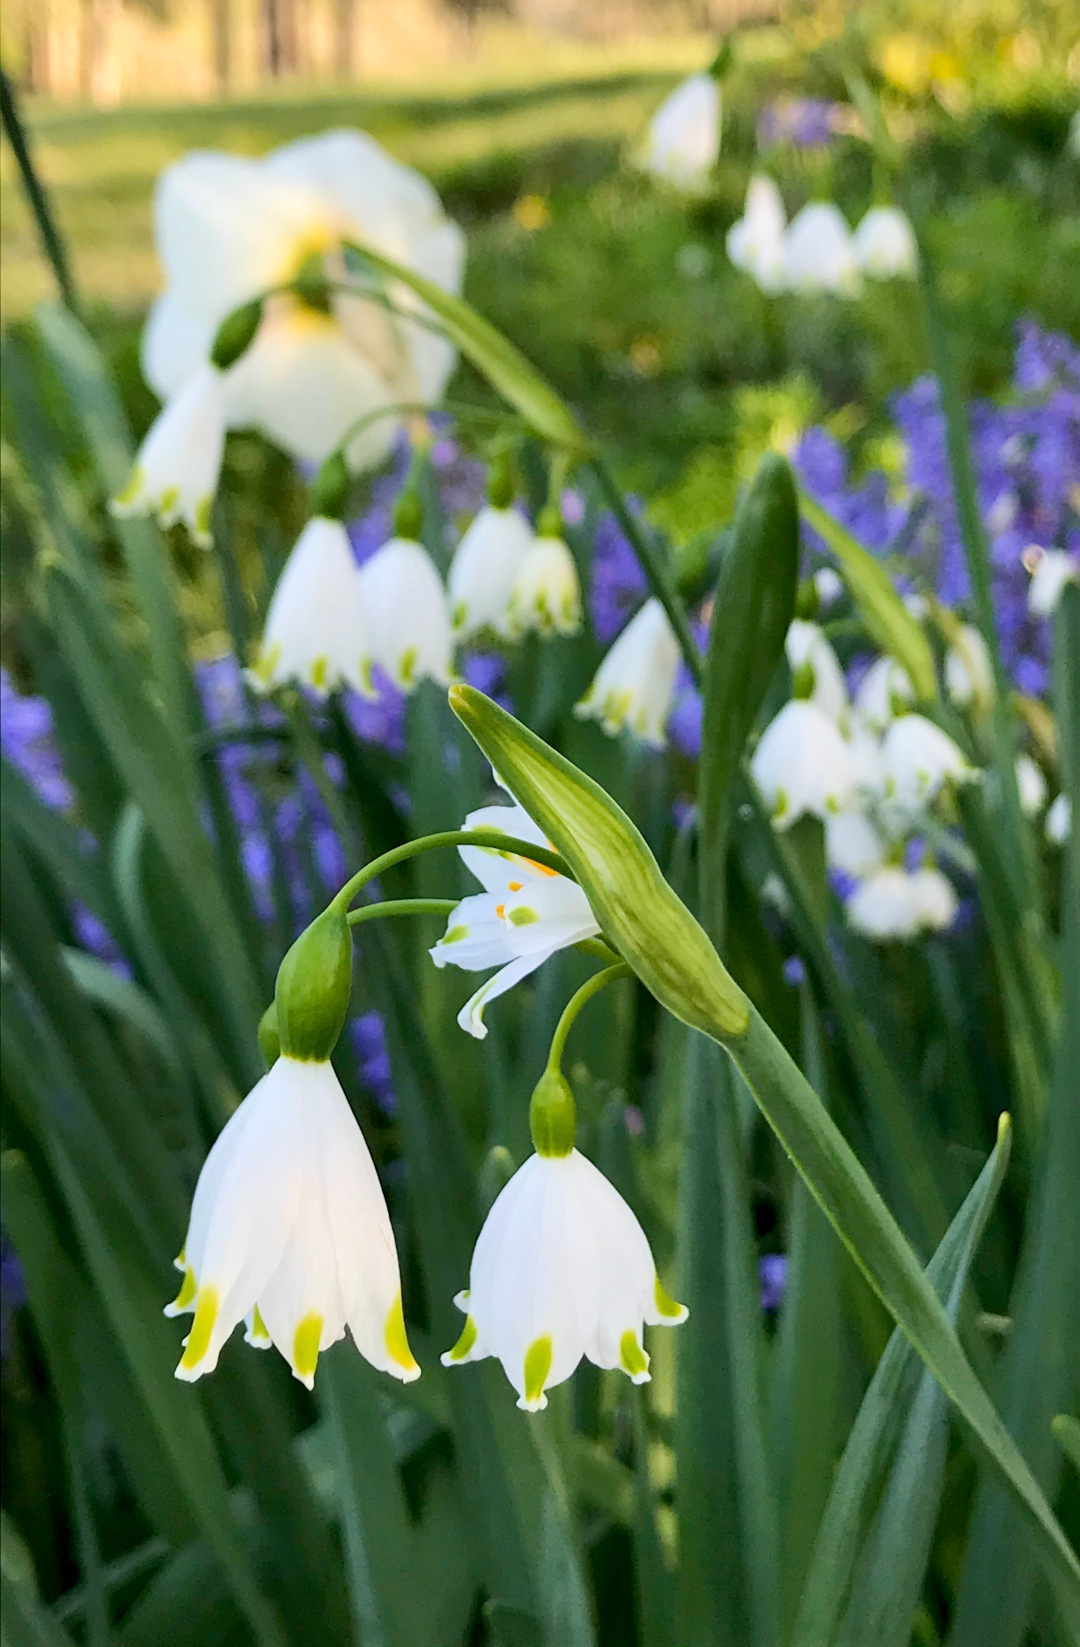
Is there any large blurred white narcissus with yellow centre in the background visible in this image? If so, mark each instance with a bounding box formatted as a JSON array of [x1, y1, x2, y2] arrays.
[[143, 130, 464, 468]]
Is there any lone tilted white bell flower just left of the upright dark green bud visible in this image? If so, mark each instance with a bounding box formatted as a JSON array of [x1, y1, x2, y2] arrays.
[[575, 595, 680, 749]]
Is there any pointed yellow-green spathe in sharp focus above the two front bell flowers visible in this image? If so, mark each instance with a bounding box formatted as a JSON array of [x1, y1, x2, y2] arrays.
[[449, 685, 749, 1041]]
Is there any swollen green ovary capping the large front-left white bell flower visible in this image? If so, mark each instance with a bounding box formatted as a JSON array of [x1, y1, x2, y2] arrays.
[[273, 904, 352, 1062]]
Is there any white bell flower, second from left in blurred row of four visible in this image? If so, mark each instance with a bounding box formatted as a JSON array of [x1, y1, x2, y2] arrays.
[[359, 537, 453, 692]]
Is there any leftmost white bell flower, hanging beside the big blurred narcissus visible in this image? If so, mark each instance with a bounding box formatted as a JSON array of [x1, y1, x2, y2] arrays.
[[110, 366, 226, 548]]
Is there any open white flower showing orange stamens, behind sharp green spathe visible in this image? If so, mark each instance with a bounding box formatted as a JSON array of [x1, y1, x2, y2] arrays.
[[431, 804, 599, 1041]]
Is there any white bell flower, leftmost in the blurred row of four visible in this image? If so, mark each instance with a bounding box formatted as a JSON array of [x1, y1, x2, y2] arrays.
[[249, 516, 372, 697]]
